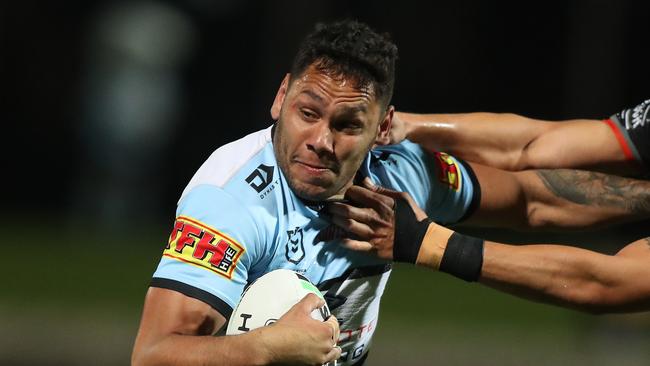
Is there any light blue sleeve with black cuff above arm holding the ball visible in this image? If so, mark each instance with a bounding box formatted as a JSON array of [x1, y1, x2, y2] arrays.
[[151, 185, 261, 318]]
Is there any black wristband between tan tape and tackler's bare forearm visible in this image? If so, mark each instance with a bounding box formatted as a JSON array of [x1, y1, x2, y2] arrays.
[[440, 232, 484, 282]]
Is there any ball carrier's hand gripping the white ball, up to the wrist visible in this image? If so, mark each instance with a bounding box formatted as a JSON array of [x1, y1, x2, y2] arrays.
[[260, 294, 341, 365]]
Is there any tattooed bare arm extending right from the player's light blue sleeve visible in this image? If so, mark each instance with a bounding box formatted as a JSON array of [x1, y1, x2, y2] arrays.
[[466, 163, 650, 229]]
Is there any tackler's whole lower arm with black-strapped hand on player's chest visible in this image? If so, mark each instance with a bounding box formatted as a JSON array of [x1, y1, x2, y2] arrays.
[[329, 185, 650, 313]]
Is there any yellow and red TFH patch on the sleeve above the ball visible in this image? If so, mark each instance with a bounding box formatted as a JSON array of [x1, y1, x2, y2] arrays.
[[163, 216, 245, 279]]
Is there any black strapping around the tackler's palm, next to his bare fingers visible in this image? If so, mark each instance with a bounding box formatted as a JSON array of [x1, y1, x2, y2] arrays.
[[393, 198, 432, 263]]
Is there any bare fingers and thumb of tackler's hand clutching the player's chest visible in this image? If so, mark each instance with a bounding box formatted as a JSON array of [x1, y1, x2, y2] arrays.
[[328, 178, 427, 260]]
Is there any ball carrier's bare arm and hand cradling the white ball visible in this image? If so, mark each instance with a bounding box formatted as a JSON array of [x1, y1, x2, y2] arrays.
[[131, 287, 340, 365]]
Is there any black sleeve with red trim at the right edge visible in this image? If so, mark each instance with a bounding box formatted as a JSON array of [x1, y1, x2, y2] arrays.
[[606, 99, 650, 169]]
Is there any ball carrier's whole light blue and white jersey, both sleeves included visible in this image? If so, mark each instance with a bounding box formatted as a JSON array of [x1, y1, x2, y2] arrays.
[[151, 127, 478, 365]]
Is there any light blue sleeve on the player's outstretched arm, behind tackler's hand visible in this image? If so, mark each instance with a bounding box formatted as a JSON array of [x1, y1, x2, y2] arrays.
[[365, 140, 480, 223]]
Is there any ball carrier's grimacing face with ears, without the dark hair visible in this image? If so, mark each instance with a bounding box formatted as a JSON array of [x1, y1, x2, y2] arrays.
[[272, 66, 390, 201]]
